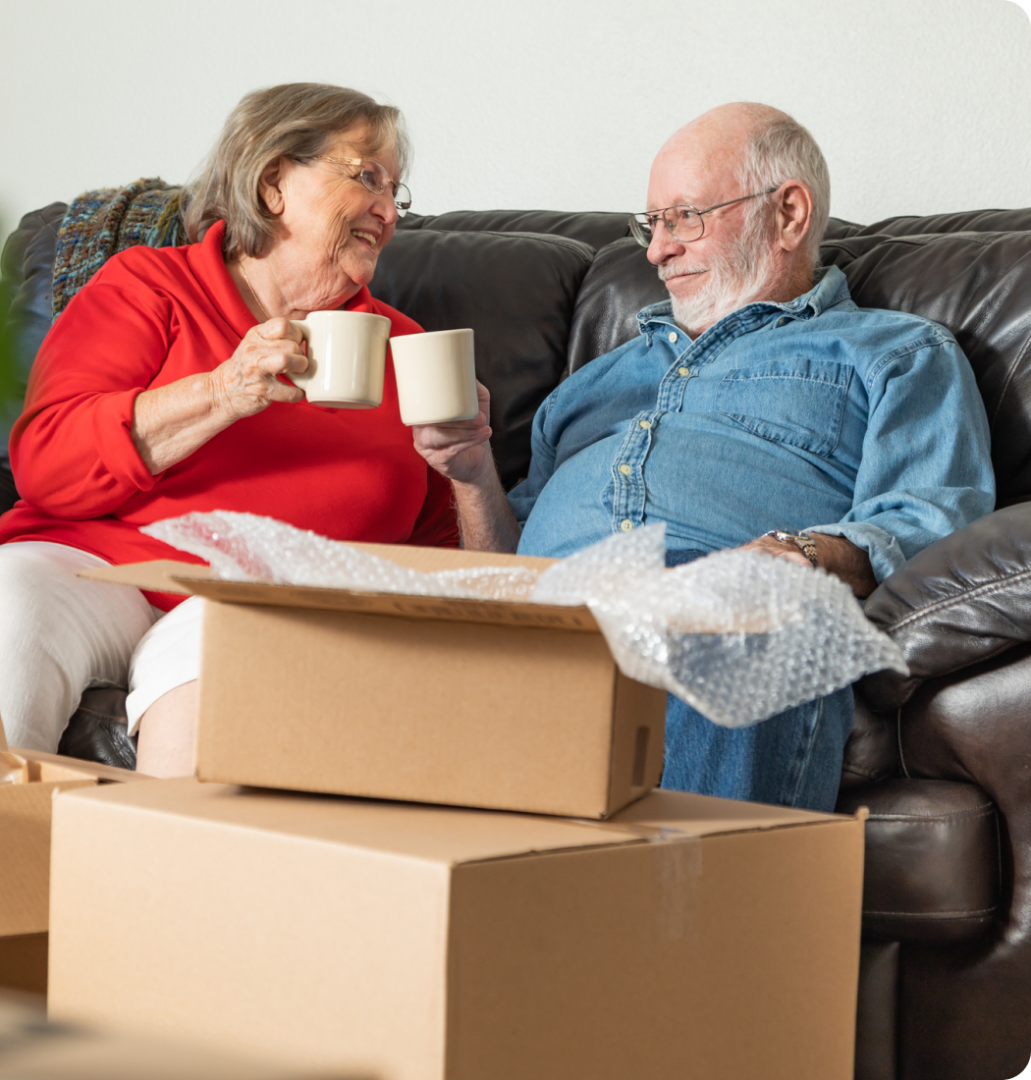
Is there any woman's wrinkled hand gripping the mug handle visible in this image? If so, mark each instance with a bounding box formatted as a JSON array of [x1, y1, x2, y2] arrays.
[[212, 319, 308, 420]]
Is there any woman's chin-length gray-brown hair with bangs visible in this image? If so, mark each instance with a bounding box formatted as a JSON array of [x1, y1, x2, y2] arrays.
[[181, 82, 410, 258]]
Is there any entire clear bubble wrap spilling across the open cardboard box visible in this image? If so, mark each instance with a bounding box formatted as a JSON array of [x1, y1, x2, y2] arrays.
[[141, 511, 907, 727]]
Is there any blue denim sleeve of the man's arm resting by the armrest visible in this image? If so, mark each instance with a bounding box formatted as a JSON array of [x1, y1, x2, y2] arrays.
[[809, 332, 995, 581]]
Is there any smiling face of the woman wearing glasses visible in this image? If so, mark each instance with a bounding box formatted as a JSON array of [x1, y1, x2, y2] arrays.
[[266, 132, 401, 311]]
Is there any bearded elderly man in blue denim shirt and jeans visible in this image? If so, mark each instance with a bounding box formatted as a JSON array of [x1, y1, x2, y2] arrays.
[[416, 104, 994, 810]]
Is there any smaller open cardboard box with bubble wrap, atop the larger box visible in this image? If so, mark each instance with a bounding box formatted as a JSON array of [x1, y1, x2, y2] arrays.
[[84, 544, 666, 818]]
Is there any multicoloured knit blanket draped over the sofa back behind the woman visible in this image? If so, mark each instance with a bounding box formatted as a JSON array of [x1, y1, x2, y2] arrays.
[[53, 177, 189, 319]]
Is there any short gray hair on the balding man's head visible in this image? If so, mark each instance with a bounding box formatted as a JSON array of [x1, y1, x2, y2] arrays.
[[738, 106, 830, 267]]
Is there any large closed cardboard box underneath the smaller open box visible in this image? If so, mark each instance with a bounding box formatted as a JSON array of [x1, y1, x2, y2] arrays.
[[50, 780, 863, 1080]]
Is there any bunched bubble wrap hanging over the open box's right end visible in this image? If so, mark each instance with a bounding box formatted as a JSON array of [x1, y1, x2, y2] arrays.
[[533, 525, 908, 728]]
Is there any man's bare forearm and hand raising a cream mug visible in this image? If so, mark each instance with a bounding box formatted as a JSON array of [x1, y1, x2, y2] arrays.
[[411, 382, 519, 553]]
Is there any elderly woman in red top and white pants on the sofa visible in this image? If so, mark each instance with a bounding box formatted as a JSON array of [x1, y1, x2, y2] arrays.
[[0, 83, 458, 775]]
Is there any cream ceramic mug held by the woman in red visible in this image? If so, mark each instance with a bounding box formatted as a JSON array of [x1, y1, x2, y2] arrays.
[[289, 311, 390, 408]]
